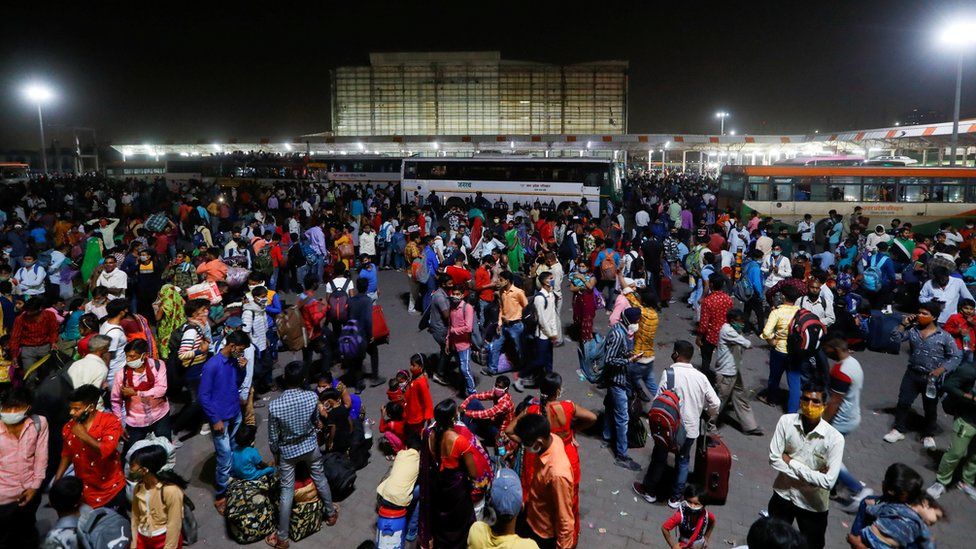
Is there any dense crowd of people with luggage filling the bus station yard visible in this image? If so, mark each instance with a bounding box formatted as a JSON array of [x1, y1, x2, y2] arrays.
[[0, 163, 976, 549]]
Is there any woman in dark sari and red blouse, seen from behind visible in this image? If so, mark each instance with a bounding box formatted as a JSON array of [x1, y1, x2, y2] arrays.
[[419, 399, 478, 549]]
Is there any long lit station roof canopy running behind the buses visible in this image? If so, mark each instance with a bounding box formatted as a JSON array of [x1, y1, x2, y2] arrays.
[[112, 119, 976, 156]]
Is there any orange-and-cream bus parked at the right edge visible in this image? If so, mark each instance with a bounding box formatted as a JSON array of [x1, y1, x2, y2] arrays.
[[717, 166, 976, 234]]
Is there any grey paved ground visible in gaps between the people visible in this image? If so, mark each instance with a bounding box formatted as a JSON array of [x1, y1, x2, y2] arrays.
[[39, 272, 976, 549]]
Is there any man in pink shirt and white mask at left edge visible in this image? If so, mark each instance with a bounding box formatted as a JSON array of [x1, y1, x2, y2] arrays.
[[0, 387, 48, 547]]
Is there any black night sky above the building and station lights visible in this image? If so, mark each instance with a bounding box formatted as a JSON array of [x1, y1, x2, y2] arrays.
[[0, 1, 976, 148]]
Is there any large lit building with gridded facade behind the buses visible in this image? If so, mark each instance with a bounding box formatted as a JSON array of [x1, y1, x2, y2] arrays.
[[332, 52, 628, 136]]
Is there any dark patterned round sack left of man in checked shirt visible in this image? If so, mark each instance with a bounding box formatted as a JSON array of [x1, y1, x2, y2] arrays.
[[224, 480, 278, 545]]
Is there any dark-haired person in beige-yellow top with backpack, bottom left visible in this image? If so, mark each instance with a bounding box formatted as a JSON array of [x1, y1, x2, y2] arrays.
[[129, 444, 186, 549]]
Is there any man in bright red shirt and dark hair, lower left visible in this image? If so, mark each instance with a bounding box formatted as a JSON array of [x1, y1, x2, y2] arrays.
[[54, 385, 131, 516]]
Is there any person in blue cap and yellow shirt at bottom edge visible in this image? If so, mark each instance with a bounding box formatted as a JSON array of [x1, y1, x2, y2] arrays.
[[468, 468, 539, 549]]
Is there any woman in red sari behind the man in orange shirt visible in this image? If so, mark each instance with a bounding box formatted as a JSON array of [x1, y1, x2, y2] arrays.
[[505, 372, 596, 539]]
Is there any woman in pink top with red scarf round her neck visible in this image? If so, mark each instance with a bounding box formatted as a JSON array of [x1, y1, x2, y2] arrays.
[[112, 339, 173, 455]]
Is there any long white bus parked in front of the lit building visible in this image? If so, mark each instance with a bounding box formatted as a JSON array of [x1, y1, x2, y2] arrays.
[[401, 157, 622, 216]]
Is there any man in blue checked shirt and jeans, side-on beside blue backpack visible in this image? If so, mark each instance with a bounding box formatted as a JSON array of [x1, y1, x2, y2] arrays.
[[603, 307, 644, 471]]
